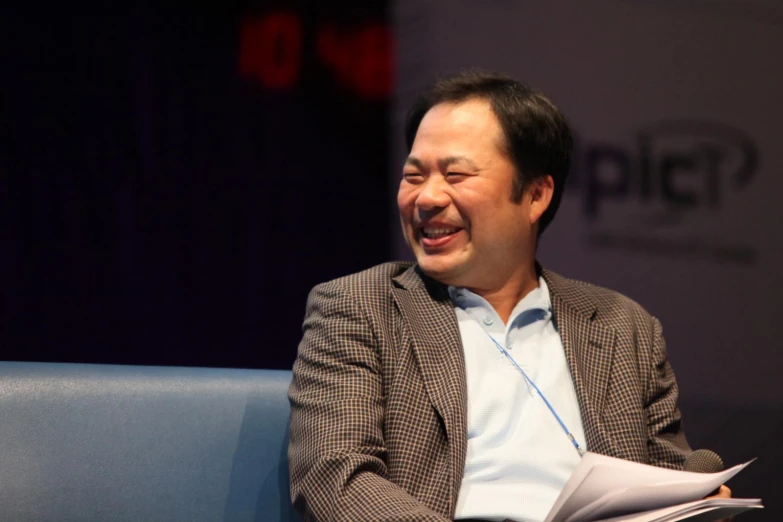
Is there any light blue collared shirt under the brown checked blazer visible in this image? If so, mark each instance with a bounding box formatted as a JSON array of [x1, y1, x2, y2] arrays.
[[449, 278, 586, 522]]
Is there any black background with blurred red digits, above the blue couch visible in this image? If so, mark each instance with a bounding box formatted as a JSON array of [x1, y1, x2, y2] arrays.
[[0, 1, 393, 368]]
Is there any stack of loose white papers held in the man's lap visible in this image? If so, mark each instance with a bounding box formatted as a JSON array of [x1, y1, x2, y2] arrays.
[[545, 453, 762, 522]]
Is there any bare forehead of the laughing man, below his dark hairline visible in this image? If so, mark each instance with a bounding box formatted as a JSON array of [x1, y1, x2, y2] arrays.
[[411, 99, 503, 155]]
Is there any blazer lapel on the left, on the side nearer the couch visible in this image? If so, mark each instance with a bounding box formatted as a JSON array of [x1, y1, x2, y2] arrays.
[[392, 265, 467, 509]]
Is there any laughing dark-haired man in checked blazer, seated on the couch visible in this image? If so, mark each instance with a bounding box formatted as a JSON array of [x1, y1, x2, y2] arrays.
[[289, 72, 728, 521]]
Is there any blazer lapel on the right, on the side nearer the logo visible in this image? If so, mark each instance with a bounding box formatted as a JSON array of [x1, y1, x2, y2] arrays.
[[542, 270, 621, 457]]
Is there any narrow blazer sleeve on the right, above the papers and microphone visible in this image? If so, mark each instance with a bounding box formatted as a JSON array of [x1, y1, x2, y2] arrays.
[[645, 318, 691, 469]]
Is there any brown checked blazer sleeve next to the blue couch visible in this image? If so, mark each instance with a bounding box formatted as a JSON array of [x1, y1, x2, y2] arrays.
[[288, 280, 448, 522]]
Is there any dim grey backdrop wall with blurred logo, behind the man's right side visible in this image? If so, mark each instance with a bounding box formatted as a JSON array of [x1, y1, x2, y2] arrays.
[[396, 0, 783, 520]]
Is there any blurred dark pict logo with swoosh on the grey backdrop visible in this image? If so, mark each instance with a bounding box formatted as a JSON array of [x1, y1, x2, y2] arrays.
[[566, 121, 759, 264]]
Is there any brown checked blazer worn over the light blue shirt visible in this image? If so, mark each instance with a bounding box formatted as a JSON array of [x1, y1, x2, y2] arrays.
[[288, 263, 690, 521]]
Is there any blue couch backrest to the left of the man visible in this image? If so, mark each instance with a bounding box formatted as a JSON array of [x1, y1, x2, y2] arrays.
[[0, 362, 299, 522]]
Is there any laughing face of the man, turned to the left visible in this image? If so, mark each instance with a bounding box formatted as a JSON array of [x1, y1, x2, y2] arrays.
[[397, 99, 534, 290]]
